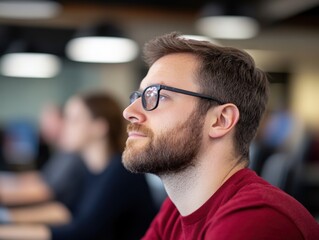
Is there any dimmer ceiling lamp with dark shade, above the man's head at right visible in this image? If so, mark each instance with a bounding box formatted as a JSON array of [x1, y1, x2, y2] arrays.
[[196, 4, 260, 39]]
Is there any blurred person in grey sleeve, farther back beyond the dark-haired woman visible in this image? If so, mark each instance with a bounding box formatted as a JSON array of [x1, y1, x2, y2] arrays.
[[0, 104, 86, 206]]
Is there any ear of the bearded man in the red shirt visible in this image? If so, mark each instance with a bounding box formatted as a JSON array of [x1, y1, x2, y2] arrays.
[[209, 103, 240, 138]]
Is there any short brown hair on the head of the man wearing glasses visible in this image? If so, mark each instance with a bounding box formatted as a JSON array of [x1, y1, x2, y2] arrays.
[[144, 33, 268, 159]]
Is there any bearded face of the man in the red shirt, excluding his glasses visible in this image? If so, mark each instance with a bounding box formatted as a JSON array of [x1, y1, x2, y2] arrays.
[[123, 54, 208, 175]]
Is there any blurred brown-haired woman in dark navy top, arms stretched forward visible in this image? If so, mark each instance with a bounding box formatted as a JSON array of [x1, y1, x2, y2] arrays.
[[0, 94, 155, 240]]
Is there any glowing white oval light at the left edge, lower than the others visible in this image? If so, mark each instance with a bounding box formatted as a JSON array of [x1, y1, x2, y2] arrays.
[[0, 53, 61, 78]]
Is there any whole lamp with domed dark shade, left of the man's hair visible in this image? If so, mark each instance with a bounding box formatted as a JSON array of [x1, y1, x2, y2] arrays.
[[66, 21, 139, 63]]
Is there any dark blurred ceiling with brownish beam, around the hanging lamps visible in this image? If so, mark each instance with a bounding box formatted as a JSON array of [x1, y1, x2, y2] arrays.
[[0, 0, 319, 70]]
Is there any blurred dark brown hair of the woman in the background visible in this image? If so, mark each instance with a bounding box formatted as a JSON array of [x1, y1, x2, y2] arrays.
[[79, 93, 125, 153]]
